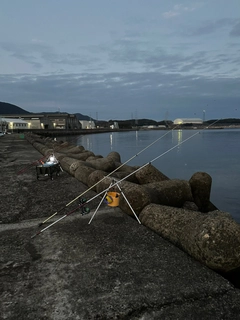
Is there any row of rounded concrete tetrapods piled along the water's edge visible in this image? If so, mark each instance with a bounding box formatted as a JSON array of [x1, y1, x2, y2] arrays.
[[26, 134, 240, 274]]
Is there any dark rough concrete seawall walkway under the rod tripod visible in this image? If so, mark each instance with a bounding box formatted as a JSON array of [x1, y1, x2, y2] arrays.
[[0, 135, 240, 320]]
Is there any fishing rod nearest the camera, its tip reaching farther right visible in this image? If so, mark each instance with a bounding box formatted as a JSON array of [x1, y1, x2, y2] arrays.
[[31, 120, 219, 238]]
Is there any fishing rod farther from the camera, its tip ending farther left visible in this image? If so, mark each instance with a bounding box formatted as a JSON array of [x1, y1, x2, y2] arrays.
[[39, 125, 179, 227]]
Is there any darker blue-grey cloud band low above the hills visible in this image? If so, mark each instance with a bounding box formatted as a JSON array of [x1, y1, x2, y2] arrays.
[[0, 72, 240, 120]]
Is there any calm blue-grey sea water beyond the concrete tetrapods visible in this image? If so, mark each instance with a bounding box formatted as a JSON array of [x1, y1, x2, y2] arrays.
[[62, 129, 240, 223]]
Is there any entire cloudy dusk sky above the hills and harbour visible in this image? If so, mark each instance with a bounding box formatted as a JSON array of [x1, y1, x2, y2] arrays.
[[0, 0, 240, 121]]
